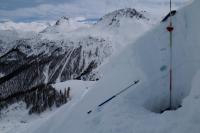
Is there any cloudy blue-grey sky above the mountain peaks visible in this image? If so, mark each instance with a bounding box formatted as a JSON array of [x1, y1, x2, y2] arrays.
[[0, 0, 188, 21]]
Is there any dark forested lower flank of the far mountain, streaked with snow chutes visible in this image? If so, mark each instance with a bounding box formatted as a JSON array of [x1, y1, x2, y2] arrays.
[[0, 36, 111, 98]]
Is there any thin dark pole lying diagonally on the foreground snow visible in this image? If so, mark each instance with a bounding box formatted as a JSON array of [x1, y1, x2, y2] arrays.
[[87, 80, 140, 114]]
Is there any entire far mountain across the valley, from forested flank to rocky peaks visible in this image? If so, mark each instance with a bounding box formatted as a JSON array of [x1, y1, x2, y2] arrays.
[[0, 9, 155, 100]]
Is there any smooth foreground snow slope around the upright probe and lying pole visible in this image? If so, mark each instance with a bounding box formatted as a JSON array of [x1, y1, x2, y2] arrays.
[[29, 0, 200, 133]]
